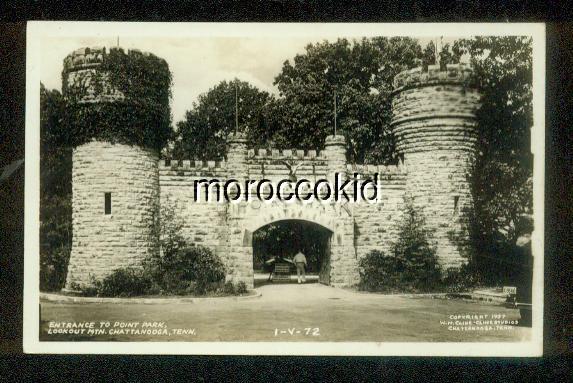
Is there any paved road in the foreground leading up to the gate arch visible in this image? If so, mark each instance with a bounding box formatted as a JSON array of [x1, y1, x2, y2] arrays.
[[41, 283, 531, 342]]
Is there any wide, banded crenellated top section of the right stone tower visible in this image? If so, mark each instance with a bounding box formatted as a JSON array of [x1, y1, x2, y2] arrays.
[[392, 64, 481, 154]]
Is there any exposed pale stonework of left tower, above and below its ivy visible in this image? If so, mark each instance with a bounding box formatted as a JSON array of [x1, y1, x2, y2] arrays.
[[62, 48, 159, 290]]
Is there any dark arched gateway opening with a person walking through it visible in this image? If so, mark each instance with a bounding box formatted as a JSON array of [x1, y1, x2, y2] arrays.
[[252, 219, 332, 286]]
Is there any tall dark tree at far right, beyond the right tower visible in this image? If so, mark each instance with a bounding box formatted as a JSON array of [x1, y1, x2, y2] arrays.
[[422, 36, 533, 284]]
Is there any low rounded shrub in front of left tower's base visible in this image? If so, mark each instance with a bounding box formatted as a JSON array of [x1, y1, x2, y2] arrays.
[[89, 267, 153, 297]]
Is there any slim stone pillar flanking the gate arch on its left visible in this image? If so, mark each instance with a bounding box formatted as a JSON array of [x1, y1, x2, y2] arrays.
[[222, 132, 254, 289]]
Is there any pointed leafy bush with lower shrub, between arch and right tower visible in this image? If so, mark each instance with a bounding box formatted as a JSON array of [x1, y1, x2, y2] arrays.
[[359, 201, 441, 292]]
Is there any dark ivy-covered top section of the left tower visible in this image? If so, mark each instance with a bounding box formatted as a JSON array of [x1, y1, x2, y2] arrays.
[[62, 48, 172, 150]]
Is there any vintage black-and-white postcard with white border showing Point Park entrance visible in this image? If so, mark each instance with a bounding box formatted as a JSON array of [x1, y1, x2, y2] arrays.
[[24, 22, 545, 356]]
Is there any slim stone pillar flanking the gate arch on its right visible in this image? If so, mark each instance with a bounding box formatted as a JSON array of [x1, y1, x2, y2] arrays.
[[323, 135, 359, 287]]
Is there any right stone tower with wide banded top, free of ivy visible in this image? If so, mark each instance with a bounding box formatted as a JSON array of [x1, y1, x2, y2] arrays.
[[392, 64, 480, 270]]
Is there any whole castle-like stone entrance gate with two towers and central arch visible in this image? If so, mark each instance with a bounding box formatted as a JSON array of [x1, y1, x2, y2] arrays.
[[64, 49, 479, 288]]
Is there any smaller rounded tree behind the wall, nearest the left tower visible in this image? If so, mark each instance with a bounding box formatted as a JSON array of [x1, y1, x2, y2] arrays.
[[172, 79, 272, 160]]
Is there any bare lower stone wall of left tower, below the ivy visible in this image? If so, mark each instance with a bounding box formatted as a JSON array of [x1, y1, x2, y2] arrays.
[[66, 141, 159, 290]]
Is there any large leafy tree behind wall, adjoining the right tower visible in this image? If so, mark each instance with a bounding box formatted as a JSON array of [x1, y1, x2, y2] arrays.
[[273, 37, 421, 163]]
